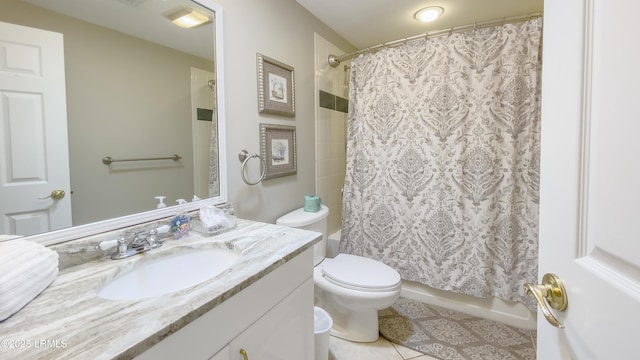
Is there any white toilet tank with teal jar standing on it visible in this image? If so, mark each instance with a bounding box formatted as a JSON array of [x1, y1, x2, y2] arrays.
[[276, 205, 329, 266]]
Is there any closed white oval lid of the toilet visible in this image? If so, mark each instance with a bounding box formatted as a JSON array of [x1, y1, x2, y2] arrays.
[[322, 254, 400, 291]]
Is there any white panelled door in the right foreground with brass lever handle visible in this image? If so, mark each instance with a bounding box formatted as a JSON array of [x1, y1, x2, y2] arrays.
[[538, 0, 640, 360]]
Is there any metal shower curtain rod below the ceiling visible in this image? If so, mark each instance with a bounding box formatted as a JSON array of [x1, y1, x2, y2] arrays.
[[327, 12, 542, 67]]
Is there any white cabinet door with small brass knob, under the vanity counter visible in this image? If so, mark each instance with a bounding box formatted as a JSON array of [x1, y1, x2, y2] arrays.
[[230, 279, 314, 360]]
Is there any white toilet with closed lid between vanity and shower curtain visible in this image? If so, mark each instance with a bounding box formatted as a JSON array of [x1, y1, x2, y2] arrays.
[[276, 205, 401, 342]]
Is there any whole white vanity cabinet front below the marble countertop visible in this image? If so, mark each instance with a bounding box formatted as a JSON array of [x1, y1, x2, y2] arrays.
[[136, 248, 314, 360]]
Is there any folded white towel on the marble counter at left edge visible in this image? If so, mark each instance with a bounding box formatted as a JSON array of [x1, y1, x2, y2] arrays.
[[0, 239, 58, 321]]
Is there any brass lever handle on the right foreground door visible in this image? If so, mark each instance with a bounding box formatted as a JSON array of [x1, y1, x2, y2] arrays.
[[524, 274, 569, 328]]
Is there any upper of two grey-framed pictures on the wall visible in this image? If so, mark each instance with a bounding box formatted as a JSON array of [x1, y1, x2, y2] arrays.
[[257, 53, 296, 117]]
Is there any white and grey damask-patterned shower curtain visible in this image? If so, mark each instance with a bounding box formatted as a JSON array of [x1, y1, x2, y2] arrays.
[[340, 18, 542, 310]]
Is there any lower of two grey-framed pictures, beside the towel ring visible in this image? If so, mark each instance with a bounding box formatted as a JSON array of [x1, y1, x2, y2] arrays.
[[260, 124, 297, 180]]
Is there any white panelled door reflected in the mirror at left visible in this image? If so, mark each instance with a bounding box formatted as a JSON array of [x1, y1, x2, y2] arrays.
[[0, 23, 71, 235]]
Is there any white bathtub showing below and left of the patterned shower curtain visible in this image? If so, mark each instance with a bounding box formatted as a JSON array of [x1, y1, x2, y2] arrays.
[[327, 230, 536, 330]]
